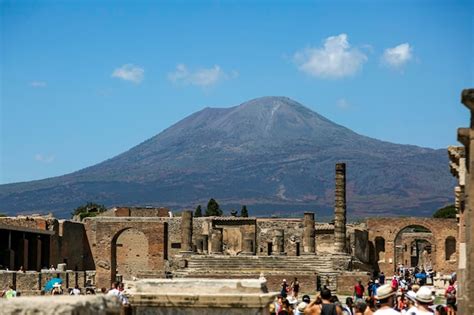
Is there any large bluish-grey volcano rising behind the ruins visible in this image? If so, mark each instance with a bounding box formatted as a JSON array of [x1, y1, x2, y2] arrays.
[[0, 97, 454, 217]]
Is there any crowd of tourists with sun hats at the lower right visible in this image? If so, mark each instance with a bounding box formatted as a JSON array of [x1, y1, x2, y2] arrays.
[[270, 270, 457, 315]]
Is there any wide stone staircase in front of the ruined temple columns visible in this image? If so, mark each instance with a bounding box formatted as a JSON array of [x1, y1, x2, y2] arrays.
[[173, 255, 334, 277]]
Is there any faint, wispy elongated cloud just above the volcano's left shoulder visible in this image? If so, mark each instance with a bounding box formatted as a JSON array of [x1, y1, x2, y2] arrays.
[[168, 64, 238, 87]]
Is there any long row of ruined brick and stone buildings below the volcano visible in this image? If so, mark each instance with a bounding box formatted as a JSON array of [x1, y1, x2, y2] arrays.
[[0, 163, 459, 292]]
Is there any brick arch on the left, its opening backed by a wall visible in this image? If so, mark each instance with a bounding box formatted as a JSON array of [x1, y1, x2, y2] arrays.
[[91, 217, 167, 287]]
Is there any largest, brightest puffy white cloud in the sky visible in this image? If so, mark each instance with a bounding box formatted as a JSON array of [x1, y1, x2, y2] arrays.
[[293, 34, 367, 79]]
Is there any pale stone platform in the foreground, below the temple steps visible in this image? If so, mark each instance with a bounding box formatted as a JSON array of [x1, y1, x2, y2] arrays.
[[129, 278, 277, 315]]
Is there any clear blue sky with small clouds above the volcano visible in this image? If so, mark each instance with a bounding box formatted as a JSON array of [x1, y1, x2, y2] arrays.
[[0, 1, 474, 183]]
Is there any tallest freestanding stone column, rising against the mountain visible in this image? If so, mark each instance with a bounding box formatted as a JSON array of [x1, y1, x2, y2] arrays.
[[334, 163, 346, 253]]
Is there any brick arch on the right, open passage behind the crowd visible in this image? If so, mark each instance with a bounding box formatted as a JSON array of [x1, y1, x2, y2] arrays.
[[367, 217, 458, 274]]
